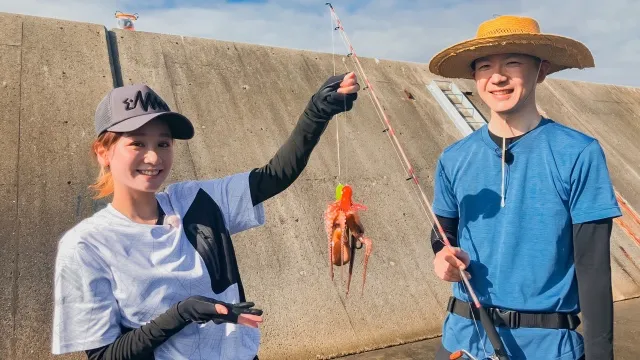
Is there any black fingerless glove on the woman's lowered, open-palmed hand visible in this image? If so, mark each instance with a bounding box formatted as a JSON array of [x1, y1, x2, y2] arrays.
[[178, 295, 262, 324]]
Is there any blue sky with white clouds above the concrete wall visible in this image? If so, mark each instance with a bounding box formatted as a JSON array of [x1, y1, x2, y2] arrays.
[[0, 0, 640, 87]]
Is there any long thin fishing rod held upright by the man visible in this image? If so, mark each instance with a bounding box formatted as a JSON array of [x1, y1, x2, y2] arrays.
[[325, 3, 509, 360]]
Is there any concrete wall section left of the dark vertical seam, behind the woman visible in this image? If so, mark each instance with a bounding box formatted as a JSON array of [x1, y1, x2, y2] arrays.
[[0, 14, 113, 359]]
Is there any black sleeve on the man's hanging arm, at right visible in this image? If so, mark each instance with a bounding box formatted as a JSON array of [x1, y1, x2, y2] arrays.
[[573, 219, 613, 360]]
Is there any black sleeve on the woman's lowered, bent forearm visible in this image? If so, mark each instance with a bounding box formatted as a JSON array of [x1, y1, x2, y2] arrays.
[[85, 305, 189, 360]]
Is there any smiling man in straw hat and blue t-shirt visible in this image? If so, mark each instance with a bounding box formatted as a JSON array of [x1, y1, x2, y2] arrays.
[[429, 16, 621, 360]]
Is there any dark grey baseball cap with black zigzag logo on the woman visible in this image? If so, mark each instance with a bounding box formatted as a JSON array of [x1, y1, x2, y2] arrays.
[[95, 84, 194, 140]]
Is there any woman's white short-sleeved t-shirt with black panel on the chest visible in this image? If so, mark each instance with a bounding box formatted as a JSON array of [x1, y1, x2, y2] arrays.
[[52, 172, 264, 360]]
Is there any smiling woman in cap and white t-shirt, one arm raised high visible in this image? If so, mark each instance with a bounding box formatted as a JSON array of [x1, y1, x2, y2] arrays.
[[52, 73, 359, 360]]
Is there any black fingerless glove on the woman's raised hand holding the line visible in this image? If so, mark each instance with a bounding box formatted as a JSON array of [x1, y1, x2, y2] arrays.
[[309, 73, 358, 118]]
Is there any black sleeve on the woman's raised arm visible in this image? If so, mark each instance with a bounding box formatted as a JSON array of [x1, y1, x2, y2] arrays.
[[249, 99, 331, 206]]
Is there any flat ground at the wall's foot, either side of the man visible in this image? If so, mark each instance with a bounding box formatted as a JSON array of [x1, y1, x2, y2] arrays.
[[339, 299, 640, 360]]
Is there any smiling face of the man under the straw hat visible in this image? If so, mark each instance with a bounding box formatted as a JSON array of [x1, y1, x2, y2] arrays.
[[473, 54, 549, 114]]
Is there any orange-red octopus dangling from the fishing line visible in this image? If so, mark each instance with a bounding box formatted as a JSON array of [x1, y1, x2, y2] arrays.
[[324, 184, 371, 295]]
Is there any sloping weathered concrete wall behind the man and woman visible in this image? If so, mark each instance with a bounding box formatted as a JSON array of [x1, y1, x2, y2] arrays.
[[0, 14, 640, 360]]
